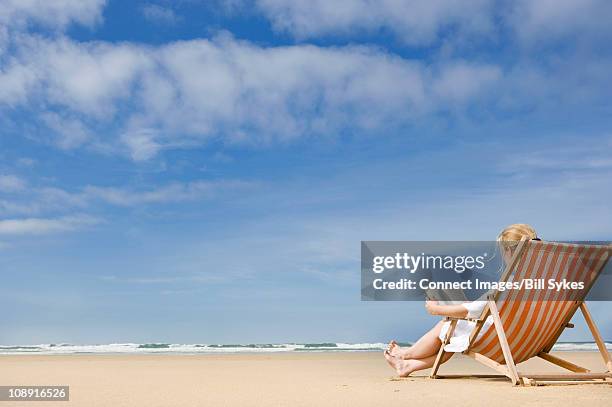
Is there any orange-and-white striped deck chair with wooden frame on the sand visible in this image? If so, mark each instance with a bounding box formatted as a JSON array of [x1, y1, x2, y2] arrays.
[[430, 239, 612, 385]]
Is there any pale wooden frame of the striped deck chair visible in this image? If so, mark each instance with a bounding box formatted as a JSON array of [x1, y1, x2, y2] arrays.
[[429, 239, 612, 386]]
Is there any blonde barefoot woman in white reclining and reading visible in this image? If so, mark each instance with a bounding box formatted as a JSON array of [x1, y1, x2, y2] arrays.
[[384, 223, 537, 377]]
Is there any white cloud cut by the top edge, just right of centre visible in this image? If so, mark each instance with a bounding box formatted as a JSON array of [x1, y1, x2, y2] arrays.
[[256, 0, 494, 45]]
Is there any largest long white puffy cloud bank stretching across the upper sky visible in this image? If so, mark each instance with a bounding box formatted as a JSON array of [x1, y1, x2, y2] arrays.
[[0, 36, 499, 160]]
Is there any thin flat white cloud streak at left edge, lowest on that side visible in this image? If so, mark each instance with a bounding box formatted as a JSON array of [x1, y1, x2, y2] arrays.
[[0, 215, 99, 235]]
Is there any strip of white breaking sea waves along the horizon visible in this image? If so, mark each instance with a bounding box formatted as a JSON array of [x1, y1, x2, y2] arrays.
[[0, 342, 612, 355]]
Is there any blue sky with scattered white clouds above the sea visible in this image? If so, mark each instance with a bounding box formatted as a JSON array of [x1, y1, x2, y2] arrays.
[[0, 0, 612, 344]]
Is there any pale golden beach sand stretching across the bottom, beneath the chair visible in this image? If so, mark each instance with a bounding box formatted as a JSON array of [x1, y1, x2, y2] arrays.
[[0, 352, 612, 407]]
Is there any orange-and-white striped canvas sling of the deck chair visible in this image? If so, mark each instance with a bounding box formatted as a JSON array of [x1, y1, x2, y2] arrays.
[[470, 241, 611, 364]]
